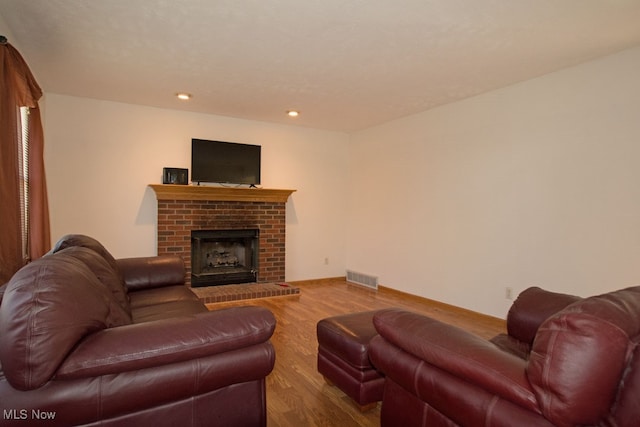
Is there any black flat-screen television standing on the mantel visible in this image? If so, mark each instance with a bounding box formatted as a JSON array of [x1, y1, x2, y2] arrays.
[[191, 138, 261, 185]]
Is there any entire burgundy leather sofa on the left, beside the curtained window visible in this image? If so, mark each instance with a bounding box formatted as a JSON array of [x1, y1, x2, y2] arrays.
[[0, 235, 275, 426]]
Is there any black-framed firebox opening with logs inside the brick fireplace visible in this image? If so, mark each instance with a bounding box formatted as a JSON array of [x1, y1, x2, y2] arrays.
[[191, 229, 260, 287]]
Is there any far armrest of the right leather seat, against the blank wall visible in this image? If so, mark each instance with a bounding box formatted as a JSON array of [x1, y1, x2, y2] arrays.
[[507, 286, 582, 346]]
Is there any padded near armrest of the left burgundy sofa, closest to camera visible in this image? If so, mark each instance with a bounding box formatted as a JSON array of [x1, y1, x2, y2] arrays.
[[55, 307, 276, 379]]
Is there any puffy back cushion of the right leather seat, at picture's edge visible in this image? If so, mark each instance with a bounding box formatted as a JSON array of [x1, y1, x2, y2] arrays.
[[527, 287, 640, 426]]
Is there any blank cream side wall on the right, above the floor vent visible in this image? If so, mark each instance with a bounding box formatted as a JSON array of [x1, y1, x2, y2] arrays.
[[347, 48, 640, 317]]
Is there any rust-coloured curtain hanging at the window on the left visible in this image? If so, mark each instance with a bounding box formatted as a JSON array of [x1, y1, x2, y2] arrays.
[[0, 43, 51, 285]]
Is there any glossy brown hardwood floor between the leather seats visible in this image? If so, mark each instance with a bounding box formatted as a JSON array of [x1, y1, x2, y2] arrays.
[[209, 279, 505, 427]]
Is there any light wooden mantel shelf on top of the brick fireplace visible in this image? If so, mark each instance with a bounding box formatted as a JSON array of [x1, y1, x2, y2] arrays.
[[149, 184, 296, 203]]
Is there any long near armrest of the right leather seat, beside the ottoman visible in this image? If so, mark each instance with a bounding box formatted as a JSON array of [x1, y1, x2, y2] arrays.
[[370, 309, 539, 411]]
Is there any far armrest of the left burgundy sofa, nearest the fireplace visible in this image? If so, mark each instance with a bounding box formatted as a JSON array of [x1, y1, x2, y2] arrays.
[[116, 255, 186, 291]]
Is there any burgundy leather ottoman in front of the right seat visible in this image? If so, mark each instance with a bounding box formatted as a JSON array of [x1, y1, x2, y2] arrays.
[[317, 310, 384, 411]]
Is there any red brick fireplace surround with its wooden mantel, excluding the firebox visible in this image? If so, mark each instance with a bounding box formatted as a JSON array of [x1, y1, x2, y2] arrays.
[[150, 184, 295, 286]]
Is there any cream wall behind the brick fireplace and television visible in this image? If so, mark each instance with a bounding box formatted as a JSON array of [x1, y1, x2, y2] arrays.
[[43, 97, 348, 280]]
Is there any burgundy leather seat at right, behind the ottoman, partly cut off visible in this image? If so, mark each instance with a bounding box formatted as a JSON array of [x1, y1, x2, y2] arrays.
[[369, 287, 640, 427]]
